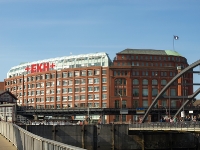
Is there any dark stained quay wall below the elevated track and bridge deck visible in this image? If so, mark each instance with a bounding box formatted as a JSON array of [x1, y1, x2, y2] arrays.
[[22, 124, 198, 150]]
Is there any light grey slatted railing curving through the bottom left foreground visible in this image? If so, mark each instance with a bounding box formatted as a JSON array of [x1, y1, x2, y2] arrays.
[[0, 121, 84, 150]]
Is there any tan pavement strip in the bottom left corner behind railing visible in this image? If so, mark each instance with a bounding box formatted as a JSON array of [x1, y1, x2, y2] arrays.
[[0, 134, 17, 150]]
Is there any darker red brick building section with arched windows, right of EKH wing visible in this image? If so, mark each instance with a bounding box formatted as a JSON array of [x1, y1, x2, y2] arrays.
[[109, 49, 193, 121]]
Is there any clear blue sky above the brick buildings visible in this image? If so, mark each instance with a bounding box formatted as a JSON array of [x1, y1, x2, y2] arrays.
[[0, 0, 200, 97]]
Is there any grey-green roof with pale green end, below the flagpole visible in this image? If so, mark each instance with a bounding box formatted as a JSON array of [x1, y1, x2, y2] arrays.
[[117, 49, 181, 56]]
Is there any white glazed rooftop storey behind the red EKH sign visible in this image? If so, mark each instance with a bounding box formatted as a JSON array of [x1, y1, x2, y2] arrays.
[[7, 52, 111, 78]]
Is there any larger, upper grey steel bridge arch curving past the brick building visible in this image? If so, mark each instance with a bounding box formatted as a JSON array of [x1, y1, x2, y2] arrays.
[[141, 60, 200, 123]]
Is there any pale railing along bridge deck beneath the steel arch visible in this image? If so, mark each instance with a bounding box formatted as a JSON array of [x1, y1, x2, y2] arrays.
[[129, 121, 200, 131]]
